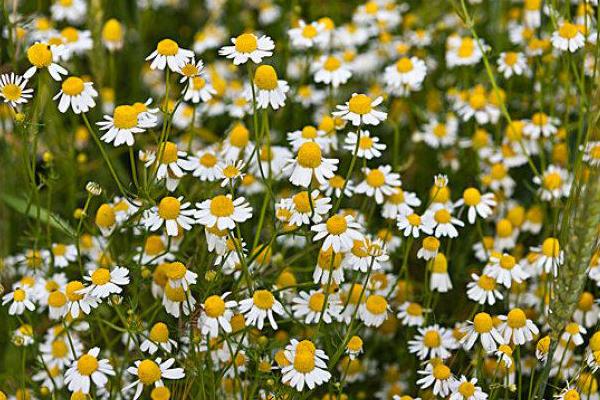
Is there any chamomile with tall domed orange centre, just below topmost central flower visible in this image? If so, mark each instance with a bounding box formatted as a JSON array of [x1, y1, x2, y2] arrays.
[[245, 65, 290, 110]]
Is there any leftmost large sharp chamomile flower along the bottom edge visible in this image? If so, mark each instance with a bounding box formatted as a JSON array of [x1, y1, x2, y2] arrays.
[[65, 347, 115, 394]]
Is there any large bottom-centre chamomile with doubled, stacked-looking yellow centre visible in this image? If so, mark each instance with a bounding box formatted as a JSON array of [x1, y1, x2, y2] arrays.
[[281, 339, 331, 392]]
